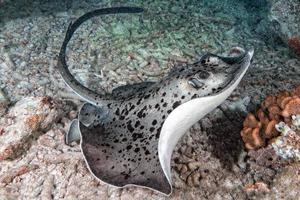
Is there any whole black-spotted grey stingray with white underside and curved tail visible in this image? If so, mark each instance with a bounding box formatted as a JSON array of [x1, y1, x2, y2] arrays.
[[58, 7, 253, 195]]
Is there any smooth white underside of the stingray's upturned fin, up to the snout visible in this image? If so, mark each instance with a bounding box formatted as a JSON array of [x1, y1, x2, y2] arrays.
[[158, 50, 253, 182]]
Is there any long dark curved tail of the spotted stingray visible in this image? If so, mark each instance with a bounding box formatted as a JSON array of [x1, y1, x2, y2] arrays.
[[57, 7, 143, 105]]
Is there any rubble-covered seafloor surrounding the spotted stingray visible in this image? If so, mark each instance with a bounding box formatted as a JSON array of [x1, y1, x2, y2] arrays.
[[0, 0, 300, 200]]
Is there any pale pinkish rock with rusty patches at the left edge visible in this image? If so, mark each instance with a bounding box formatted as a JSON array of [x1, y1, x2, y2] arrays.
[[0, 97, 62, 161]]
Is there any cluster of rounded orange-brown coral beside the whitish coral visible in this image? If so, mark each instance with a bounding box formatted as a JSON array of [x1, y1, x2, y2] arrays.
[[241, 86, 300, 150]]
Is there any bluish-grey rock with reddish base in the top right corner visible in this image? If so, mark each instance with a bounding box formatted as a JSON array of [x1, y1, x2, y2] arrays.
[[269, 0, 300, 56]]
